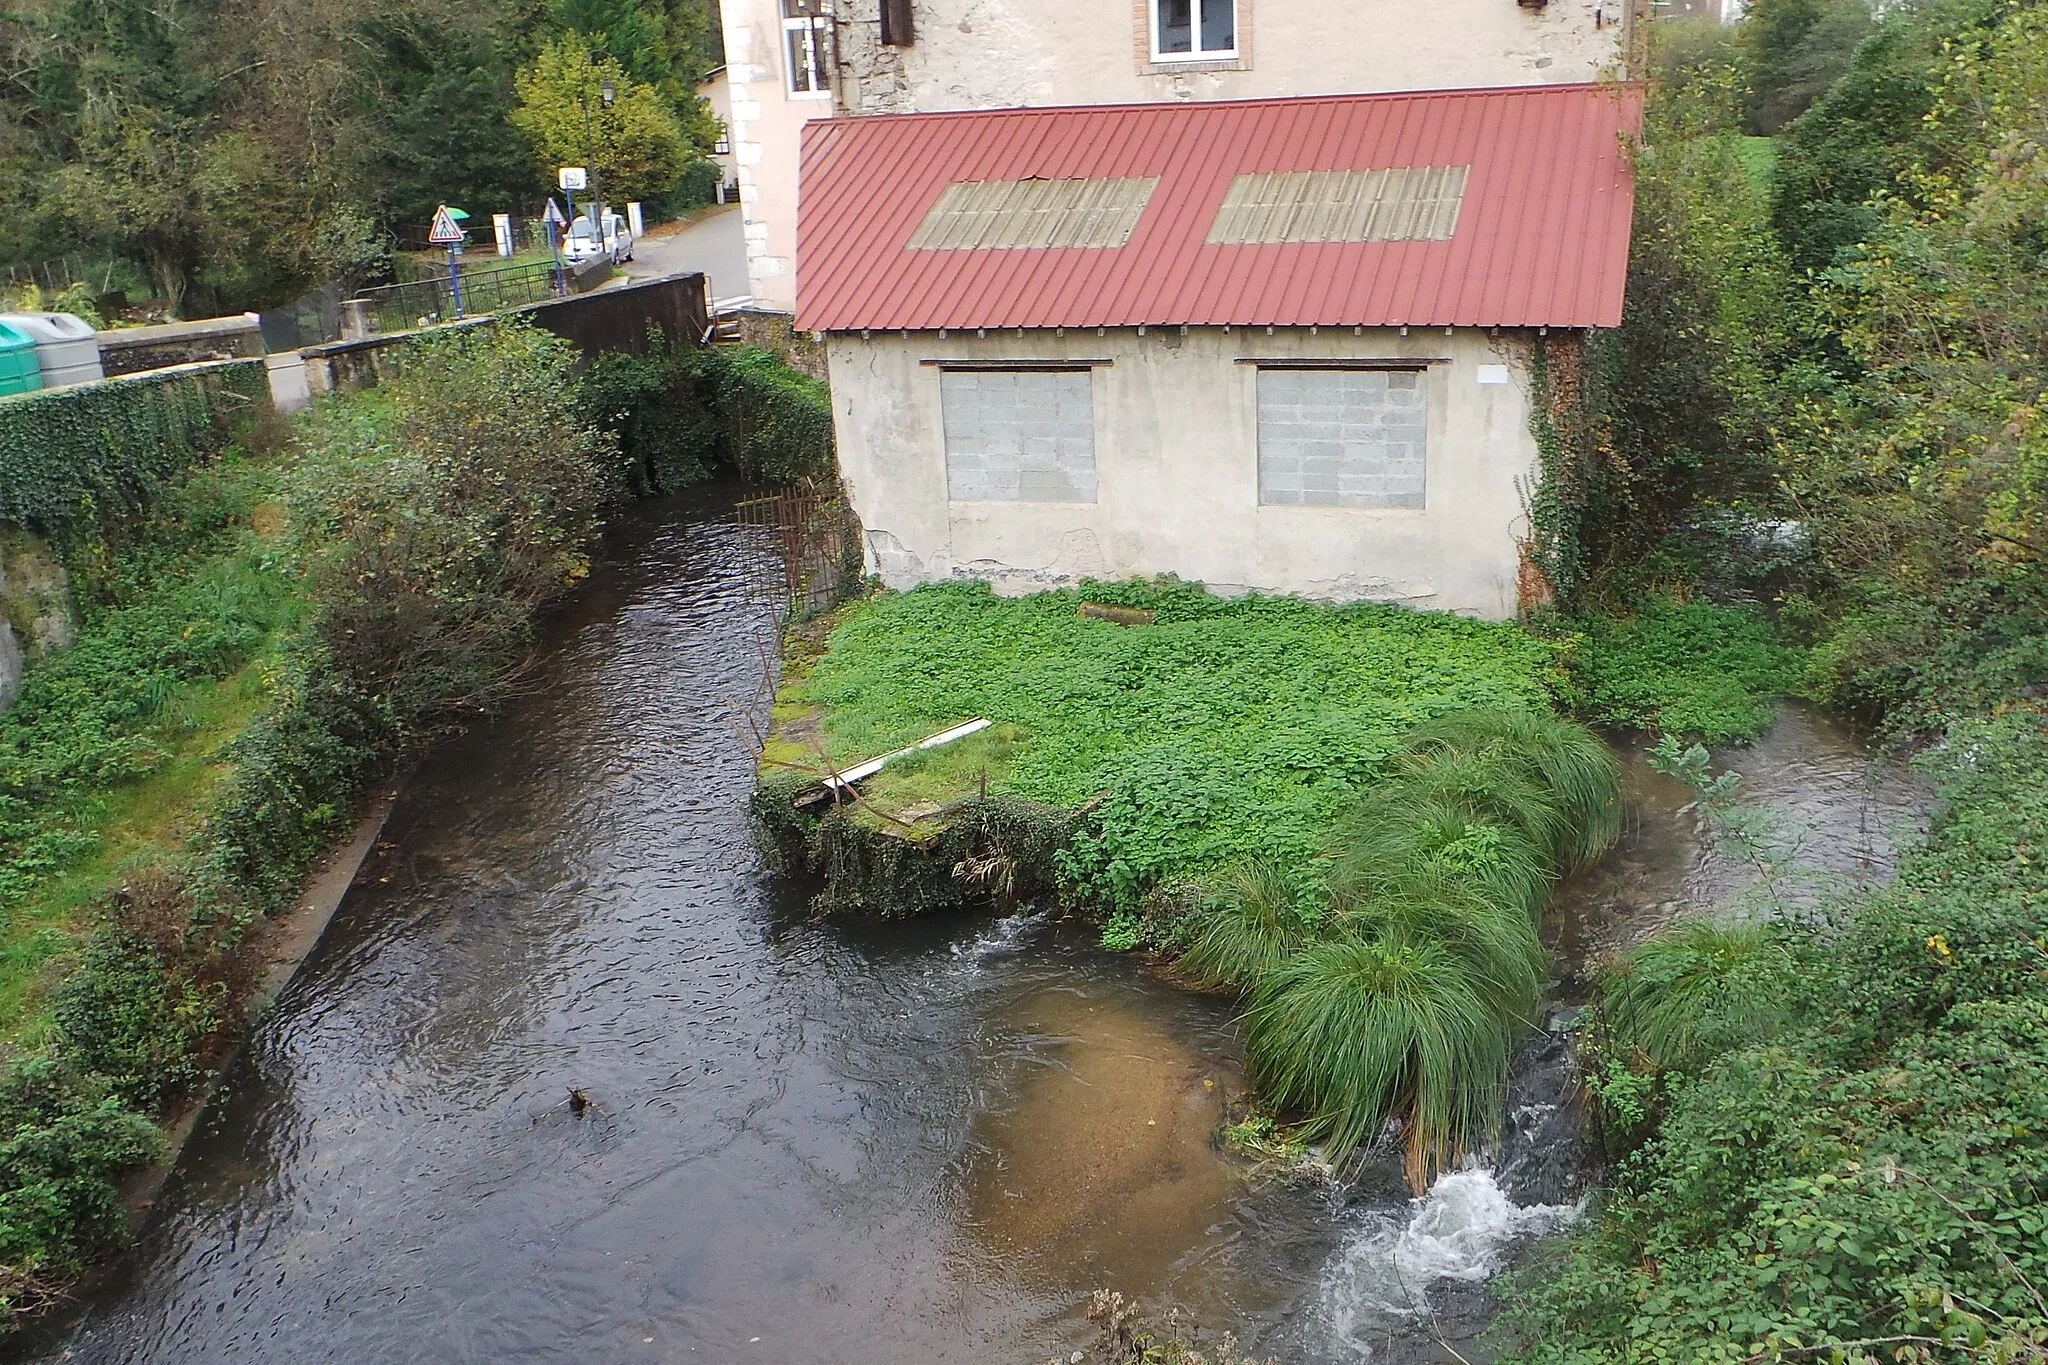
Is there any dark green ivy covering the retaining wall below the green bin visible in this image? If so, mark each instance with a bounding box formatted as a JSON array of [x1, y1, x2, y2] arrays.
[[0, 360, 268, 540]]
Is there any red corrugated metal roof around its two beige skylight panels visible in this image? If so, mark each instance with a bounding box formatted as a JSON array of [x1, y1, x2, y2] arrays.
[[797, 86, 1642, 332]]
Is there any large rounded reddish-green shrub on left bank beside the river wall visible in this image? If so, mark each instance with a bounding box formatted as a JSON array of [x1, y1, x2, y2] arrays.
[[287, 323, 618, 729]]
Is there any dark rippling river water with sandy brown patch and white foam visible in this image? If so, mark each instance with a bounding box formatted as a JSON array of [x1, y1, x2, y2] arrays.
[[61, 495, 1921, 1365]]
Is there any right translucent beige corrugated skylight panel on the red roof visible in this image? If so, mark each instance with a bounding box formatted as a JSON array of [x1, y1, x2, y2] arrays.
[[1208, 166, 1473, 246]]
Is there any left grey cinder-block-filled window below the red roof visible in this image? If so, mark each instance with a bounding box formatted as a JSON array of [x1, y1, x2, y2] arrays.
[[938, 368, 1096, 501]]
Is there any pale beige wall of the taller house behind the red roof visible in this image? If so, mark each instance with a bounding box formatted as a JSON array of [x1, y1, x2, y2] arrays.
[[725, 0, 1632, 309]]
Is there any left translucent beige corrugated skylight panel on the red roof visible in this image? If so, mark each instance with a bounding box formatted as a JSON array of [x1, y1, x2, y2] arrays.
[[909, 176, 1159, 252]]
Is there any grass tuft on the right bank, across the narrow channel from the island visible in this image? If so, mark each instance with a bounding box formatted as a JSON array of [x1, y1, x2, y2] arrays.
[[1599, 919, 1790, 1070]]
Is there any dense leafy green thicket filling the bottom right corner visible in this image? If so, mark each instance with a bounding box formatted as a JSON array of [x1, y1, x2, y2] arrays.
[[1513, 708, 2048, 1361]]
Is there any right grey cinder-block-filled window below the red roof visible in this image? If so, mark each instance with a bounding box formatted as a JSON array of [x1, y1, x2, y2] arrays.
[[1260, 364, 1430, 508]]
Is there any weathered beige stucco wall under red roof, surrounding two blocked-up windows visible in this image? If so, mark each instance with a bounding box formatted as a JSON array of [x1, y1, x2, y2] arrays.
[[825, 327, 1536, 618]]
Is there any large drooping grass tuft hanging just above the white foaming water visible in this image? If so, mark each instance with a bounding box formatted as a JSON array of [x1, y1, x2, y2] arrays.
[[1245, 933, 1516, 1187]]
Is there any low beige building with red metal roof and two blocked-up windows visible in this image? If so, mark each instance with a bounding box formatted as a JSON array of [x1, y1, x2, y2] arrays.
[[797, 85, 1640, 618]]
